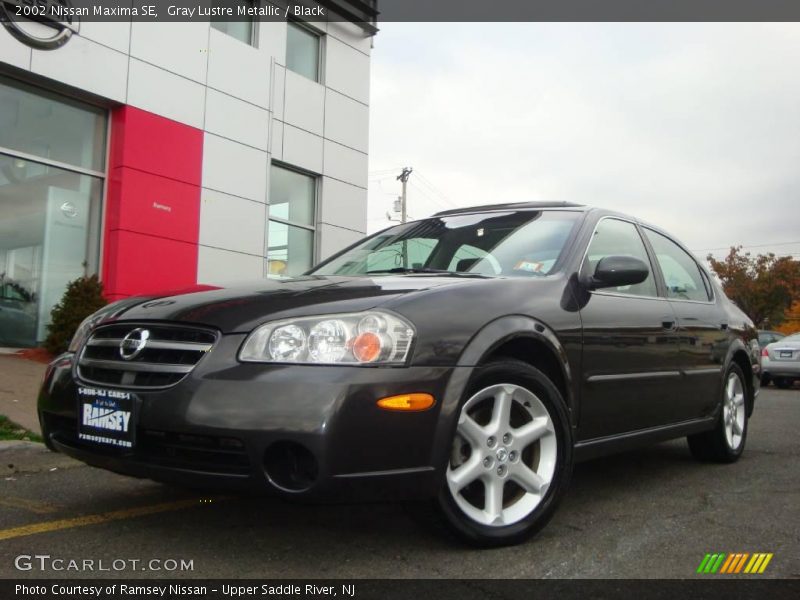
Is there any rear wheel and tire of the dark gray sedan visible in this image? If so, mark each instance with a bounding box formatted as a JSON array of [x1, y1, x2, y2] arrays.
[[687, 363, 752, 463]]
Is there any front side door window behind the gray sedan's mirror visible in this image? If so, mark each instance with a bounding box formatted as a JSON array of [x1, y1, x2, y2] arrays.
[[583, 219, 658, 296]]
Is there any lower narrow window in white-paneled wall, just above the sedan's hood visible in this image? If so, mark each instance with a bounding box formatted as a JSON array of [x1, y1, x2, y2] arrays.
[[267, 165, 317, 277]]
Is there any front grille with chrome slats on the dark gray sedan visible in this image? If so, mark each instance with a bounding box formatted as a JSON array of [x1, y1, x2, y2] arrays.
[[77, 323, 217, 388]]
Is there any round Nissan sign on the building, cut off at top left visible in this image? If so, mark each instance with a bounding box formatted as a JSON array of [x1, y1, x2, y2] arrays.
[[0, 0, 80, 50]]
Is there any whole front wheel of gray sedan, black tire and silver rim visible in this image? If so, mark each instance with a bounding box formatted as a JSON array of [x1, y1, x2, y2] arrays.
[[437, 359, 572, 547]]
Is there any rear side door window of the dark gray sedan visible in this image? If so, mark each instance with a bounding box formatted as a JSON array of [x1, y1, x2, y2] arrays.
[[645, 228, 712, 302]]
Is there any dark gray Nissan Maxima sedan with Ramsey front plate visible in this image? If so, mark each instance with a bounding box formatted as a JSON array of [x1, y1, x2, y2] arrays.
[[39, 204, 760, 545]]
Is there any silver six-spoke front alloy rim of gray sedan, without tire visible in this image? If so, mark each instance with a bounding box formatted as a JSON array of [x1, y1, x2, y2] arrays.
[[447, 384, 558, 527]]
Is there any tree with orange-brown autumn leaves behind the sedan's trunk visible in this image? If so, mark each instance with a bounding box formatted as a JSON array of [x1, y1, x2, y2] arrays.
[[708, 246, 800, 328]]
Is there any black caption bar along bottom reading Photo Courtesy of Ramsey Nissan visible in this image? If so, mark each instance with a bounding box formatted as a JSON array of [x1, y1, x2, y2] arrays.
[[0, 575, 800, 600]]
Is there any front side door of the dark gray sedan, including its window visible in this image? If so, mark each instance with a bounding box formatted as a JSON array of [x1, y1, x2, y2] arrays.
[[579, 217, 680, 440]]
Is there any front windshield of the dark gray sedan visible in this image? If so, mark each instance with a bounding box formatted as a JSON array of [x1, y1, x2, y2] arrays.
[[308, 210, 580, 277]]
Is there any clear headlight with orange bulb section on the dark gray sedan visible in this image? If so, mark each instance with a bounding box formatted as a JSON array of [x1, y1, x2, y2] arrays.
[[239, 311, 414, 365]]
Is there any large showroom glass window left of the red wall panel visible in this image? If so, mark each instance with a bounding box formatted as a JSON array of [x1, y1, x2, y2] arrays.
[[0, 78, 107, 346]]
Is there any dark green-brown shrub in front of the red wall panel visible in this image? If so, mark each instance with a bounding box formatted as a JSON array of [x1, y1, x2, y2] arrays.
[[44, 275, 106, 354]]
